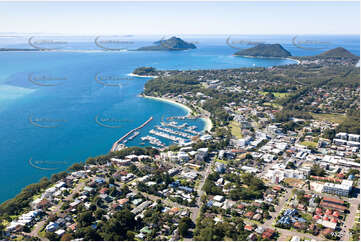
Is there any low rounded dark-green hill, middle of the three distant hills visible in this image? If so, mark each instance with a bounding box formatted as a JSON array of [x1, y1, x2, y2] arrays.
[[234, 44, 291, 58]]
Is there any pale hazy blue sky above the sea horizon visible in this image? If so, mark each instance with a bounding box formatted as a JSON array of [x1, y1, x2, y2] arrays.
[[0, 1, 360, 35]]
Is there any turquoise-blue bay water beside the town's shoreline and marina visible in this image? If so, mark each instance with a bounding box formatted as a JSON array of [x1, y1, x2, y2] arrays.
[[0, 36, 359, 202]]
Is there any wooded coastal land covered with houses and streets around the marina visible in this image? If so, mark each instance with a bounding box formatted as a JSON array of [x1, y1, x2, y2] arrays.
[[0, 39, 360, 241]]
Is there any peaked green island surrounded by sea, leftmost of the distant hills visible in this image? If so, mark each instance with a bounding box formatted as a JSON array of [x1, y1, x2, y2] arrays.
[[136, 36, 197, 51]]
